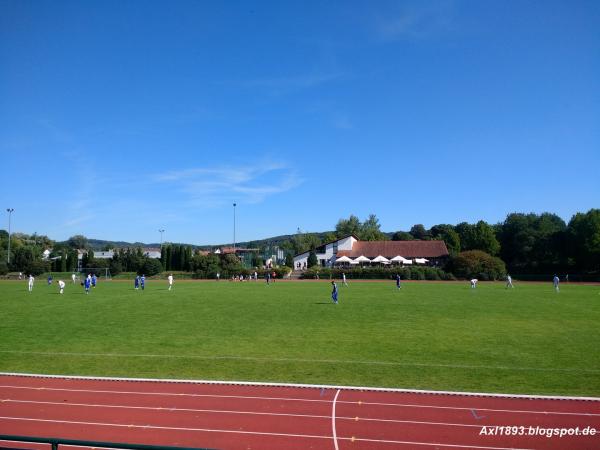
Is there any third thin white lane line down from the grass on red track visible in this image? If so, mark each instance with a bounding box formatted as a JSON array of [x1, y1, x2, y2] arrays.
[[0, 416, 533, 450]]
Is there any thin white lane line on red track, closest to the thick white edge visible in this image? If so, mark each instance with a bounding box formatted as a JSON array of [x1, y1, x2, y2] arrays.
[[0, 385, 600, 417]]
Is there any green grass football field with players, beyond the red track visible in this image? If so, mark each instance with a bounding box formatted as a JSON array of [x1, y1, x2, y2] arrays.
[[0, 281, 600, 396]]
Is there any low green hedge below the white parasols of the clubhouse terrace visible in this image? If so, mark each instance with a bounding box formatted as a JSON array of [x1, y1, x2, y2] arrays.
[[302, 267, 456, 280]]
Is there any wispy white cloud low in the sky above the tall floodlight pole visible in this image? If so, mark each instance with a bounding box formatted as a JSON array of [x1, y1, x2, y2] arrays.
[[154, 163, 302, 207]]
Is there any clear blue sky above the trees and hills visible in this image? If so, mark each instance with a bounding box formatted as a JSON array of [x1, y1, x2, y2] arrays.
[[0, 0, 600, 244]]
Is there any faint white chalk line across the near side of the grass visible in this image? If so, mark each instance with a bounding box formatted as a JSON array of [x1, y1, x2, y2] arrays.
[[0, 350, 600, 373]]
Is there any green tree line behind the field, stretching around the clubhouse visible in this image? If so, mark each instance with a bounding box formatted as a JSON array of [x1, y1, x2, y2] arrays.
[[0, 209, 600, 276]]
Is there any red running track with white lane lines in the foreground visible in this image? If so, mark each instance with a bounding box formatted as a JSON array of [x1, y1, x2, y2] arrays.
[[0, 375, 600, 450]]
